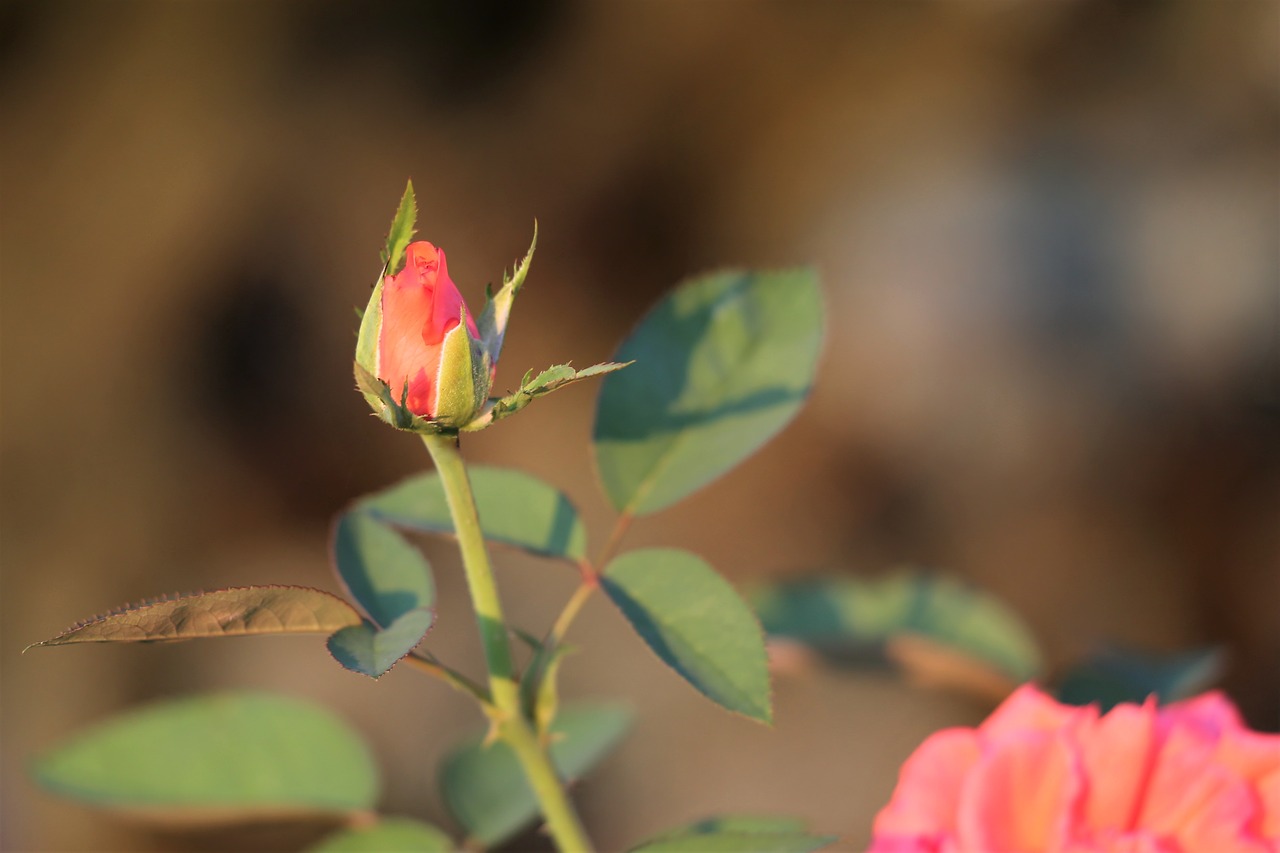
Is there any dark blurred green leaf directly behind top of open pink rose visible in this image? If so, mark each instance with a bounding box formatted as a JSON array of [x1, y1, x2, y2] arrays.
[[1057, 647, 1225, 711]]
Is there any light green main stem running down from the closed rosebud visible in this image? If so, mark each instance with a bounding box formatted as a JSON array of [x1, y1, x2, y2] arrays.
[[422, 435, 591, 853]]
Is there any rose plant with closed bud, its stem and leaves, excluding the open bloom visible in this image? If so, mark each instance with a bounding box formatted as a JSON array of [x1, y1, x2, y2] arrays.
[[36, 186, 829, 852]]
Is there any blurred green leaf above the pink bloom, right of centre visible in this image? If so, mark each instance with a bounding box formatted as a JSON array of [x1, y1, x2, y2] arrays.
[[751, 570, 1042, 684]]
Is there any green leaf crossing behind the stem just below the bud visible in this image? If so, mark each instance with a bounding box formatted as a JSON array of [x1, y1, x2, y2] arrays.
[[357, 465, 586, 562]]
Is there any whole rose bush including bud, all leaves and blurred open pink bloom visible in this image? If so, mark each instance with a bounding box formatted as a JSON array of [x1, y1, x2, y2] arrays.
[[22, 180, 1280, 853]]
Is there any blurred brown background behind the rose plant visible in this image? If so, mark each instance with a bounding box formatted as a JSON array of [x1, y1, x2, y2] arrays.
[[0, 0, 1280, 850]]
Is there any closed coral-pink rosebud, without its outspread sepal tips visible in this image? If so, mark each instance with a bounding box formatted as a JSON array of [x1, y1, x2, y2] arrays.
[[357, 241, 493, 432]]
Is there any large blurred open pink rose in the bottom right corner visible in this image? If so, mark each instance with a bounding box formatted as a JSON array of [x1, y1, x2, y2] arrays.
[[870, 685, 1280, 853]]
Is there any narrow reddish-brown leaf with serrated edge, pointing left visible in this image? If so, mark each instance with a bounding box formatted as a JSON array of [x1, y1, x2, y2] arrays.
[[28, 587, 360, 648]]
